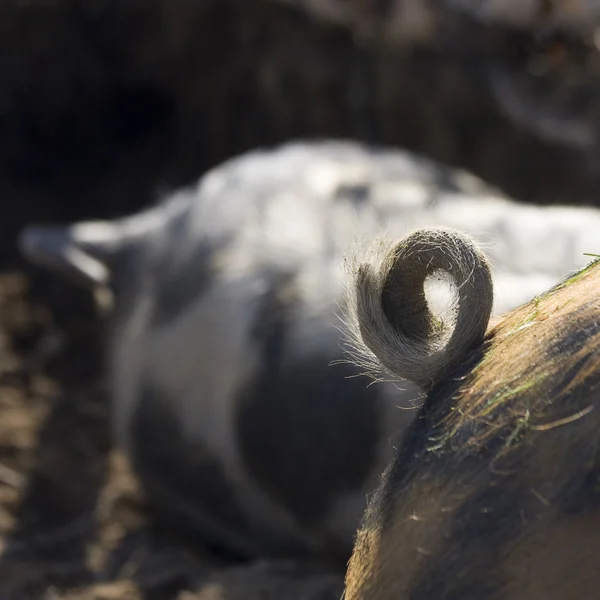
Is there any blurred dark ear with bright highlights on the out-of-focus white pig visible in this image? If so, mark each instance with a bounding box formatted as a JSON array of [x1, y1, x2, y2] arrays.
[[17, 221, 123, 287]]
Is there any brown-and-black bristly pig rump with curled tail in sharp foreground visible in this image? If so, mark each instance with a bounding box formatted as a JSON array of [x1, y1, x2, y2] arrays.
[[344, 232, 600, 600]]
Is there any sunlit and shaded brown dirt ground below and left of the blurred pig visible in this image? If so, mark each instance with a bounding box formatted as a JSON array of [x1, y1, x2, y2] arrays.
[[0, 259, 341, 600]]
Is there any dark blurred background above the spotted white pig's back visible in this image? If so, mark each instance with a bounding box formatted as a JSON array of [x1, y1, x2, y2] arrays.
[[0, 0, 600, 251]]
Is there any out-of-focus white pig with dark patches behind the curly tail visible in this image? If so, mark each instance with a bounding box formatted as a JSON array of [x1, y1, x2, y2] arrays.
[[20, 141, 600, 561]]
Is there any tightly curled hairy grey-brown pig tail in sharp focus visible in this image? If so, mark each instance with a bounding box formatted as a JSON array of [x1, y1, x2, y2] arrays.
[[342, 228, 493, 389]]
